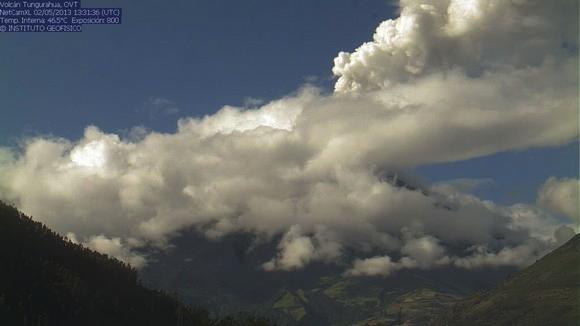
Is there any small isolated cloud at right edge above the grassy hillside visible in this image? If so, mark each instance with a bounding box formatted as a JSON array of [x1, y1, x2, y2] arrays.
[[538, 177, 580, 223]]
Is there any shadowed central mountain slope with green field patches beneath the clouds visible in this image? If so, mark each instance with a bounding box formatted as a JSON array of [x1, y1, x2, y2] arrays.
[[141, 230, 513, 326]]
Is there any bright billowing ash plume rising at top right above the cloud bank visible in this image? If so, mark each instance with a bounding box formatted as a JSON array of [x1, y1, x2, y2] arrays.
[[333, 0, 578, 92]]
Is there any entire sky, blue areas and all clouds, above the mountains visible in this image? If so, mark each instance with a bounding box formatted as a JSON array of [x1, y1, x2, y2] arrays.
[[0, 0, 578, 275]]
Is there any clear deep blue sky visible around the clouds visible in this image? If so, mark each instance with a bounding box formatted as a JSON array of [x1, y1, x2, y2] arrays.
[[0, 0, 578, 204]]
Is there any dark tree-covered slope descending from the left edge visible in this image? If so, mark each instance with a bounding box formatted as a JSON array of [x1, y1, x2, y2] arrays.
[[0, 202, 270, 326]]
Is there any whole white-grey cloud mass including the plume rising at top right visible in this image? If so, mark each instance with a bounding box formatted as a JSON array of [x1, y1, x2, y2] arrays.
[[0, 0, 578, 275]]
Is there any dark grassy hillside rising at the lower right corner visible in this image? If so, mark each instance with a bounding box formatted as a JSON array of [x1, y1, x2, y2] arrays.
[[435, 235, 580, 326]]
